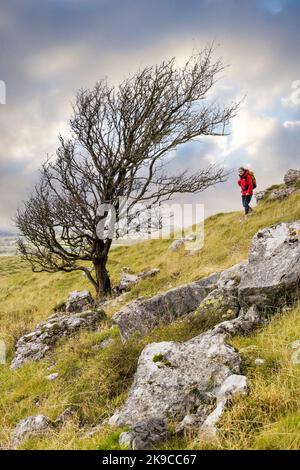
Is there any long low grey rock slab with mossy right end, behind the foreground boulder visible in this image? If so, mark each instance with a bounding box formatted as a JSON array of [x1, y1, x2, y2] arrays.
[[113, 262, 247, 340]]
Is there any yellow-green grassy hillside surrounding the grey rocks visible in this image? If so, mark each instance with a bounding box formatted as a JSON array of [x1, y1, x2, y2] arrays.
[[0, 193, 300, 449]]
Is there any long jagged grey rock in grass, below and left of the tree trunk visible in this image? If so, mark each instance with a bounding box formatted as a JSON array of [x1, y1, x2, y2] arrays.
[[11, 310, 105, 369]]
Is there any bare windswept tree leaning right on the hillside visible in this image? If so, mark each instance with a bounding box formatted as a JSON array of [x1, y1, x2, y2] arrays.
[[16, 47, 237, 296]]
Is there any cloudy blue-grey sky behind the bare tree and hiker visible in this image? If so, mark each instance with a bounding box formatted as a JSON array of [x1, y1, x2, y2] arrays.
[[0, 0, 300, 228]]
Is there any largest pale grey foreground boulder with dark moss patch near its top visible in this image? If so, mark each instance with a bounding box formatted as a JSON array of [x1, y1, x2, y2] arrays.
[[109, 307, 262, 444]]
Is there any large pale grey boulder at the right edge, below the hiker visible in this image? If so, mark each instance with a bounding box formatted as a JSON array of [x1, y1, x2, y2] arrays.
[[238, 221, 300, 311]]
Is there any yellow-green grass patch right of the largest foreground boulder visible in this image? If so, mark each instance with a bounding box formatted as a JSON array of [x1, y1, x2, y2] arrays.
[[182, 305, 300, 450]]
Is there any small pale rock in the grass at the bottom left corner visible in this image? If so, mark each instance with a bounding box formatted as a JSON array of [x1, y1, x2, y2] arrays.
[[11, 415, 52, 447]]
